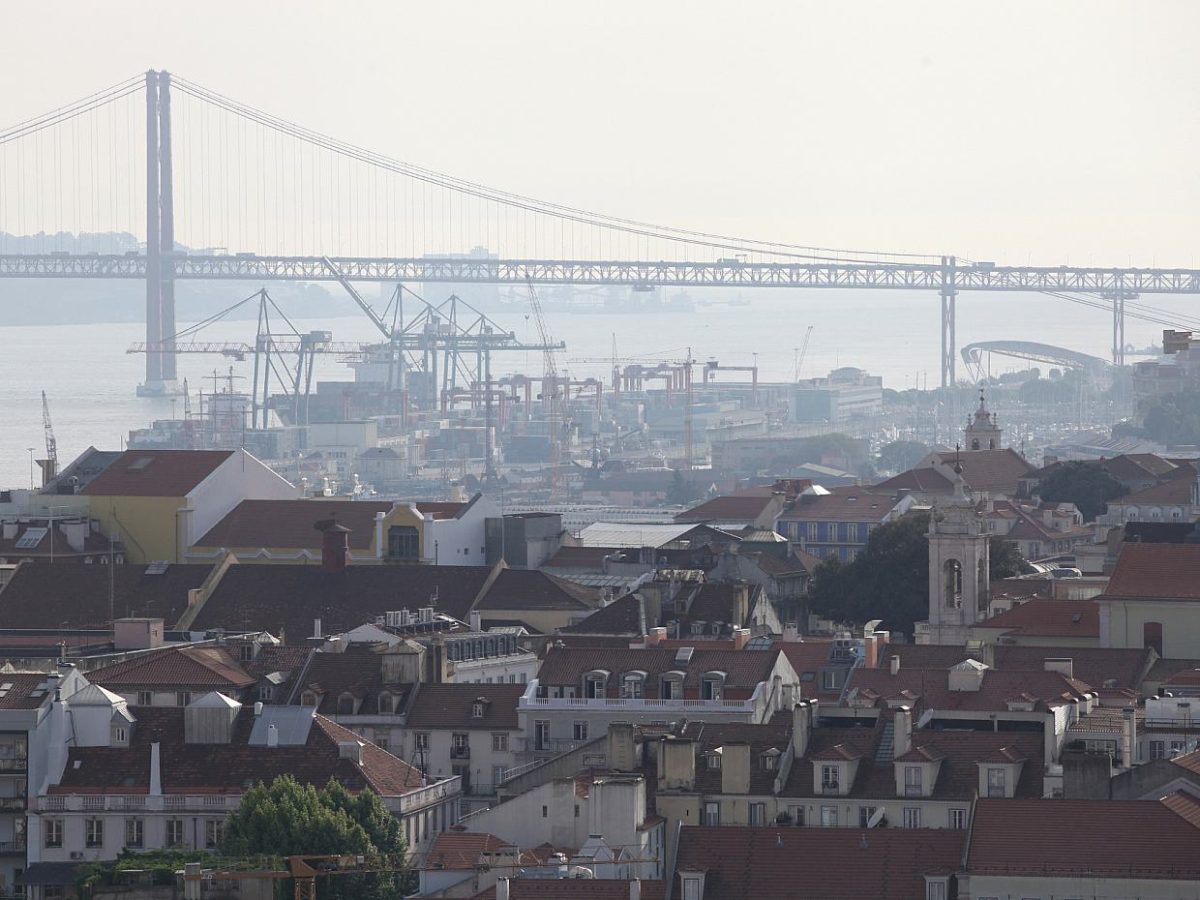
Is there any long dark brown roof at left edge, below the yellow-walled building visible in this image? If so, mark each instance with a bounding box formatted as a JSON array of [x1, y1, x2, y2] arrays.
[[0, 563, 212, 629]]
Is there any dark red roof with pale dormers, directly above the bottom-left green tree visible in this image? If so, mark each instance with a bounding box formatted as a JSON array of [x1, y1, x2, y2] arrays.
[[50, 707, 421, 796]]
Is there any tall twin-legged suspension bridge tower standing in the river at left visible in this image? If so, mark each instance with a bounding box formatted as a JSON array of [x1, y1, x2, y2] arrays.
[[138, 70, 179, 397]]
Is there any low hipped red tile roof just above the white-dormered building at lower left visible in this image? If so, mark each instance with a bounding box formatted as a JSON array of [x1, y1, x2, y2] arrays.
[[88, 647, 254, 694]]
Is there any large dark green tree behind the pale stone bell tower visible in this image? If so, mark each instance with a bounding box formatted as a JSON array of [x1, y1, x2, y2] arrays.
[[809, 512, 1032, 635]]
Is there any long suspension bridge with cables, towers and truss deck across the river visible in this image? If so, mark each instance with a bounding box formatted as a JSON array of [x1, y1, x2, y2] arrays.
[[0, 71, 1200, 394]]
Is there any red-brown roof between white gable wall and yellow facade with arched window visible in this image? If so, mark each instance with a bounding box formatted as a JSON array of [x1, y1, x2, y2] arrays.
[[196, 499, 392, 551]]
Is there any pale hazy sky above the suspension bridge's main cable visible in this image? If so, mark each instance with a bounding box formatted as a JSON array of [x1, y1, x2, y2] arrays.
[[0, 0, 1200, 265]]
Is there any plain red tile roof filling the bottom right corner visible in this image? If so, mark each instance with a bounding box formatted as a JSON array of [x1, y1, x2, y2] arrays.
[[967, 799, 1200, 893]]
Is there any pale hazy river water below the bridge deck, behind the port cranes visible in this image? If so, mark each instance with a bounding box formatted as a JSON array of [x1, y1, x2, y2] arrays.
[[0, 288, 1195, 487]]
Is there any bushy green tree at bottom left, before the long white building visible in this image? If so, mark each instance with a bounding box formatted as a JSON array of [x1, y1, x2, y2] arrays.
[[221, 775, 408, 900]]
